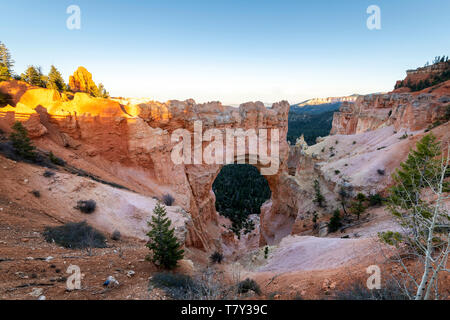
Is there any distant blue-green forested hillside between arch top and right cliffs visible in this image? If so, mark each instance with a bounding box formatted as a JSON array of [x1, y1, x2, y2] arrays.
[[287, 102, 342, 145]]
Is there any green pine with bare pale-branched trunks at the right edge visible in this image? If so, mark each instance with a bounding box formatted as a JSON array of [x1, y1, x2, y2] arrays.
[[379, 133, 450, 300]]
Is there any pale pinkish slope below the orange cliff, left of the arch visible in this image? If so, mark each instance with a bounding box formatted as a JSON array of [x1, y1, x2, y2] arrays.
[[0, 156, 192, 243]]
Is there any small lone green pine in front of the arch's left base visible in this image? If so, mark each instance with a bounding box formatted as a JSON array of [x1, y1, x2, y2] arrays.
[[146, 202, 184, 269]]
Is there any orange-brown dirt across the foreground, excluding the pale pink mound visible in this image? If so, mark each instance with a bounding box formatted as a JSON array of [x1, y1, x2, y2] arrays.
[[0, 192, 384, 300]]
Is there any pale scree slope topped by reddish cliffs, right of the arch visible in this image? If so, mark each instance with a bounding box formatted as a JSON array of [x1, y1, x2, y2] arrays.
[[284, 68, 450, 245]]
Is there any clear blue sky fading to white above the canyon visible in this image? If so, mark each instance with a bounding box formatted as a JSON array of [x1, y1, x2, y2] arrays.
[[0, 0, 450, 104]]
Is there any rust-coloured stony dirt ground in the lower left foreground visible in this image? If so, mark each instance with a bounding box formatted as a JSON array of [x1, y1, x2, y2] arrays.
[[0, 197, 175, 300]]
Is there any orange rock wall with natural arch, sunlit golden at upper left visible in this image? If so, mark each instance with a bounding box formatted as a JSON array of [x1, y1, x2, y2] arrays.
[[0, 82, 289, 250]]
